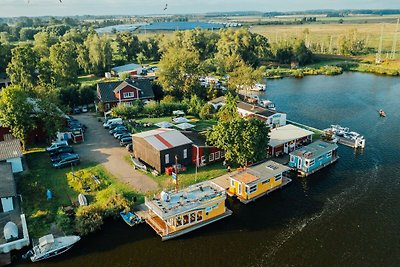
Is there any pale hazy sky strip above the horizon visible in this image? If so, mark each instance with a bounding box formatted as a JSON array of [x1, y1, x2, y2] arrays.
[[0, 0, 400, 17]]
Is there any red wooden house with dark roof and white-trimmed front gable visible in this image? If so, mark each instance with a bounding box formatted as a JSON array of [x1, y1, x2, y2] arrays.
[[97, 79, 154, 111]]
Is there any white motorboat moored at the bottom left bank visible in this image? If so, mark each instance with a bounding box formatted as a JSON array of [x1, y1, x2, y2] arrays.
[[24, 234, 81, 262]]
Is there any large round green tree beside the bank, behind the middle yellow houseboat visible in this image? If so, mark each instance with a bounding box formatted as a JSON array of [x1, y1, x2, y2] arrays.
[[206, 117, 269, 166]]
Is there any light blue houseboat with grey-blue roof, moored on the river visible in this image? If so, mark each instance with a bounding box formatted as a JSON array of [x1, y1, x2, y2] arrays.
[[289, 140, 339, 176]]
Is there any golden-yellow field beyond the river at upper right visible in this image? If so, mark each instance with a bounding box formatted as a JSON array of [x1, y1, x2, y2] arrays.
[[251, 20, 400, 52]]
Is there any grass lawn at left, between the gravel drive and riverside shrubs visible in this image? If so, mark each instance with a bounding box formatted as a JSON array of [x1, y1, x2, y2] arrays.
[[17, 148, 143, 238]]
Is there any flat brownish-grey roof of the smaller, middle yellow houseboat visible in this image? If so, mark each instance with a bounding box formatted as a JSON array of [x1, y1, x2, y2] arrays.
[[231, 160, 290, 185]]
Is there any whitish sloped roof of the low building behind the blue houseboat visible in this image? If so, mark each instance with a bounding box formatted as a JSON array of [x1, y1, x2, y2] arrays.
[[269, 124, 314, 147]]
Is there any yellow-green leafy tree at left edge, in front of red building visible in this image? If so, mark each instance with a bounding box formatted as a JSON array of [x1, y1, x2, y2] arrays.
[[0, 85, 36, 150]]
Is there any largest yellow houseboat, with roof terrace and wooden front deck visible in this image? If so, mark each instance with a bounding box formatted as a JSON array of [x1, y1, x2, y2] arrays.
[[145, 181, 232, 241]]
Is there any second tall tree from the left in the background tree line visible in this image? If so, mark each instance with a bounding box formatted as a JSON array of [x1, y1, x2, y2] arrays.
[[49, 42, 78, 86]]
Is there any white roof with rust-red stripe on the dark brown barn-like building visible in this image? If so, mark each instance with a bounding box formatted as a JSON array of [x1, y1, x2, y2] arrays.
[[133, 128, 193, 151]]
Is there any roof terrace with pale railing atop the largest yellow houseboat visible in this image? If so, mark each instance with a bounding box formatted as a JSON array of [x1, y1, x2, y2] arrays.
[[145, 181, 226, 219]]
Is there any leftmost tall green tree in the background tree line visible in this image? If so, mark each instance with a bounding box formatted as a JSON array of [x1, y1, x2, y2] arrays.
[[7, 45, 39, 89]]
